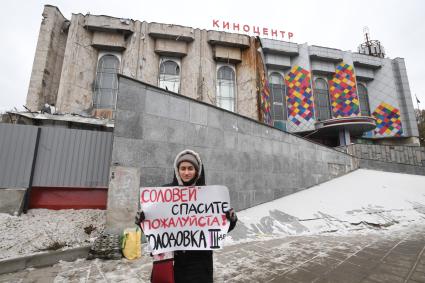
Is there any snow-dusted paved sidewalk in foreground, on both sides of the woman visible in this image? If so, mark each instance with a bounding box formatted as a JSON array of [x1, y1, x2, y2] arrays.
[[0, 225, 425, 283]]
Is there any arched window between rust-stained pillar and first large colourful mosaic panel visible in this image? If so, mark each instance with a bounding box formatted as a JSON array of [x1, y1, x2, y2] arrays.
[[269, 72, 287, 121]]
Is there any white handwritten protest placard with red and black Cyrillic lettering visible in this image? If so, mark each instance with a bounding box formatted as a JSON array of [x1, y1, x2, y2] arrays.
[[140, 186, 230, 254]]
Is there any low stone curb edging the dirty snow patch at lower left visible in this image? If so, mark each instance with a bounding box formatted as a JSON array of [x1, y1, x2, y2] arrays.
[[0, 246, 90, 274]]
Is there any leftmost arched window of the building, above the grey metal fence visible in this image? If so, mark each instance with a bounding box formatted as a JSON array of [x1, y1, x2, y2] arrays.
[[93, 54, 120, 109]]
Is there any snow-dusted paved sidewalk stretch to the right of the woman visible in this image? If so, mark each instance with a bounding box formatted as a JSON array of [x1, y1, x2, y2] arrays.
[[216, 227, 425, 283]]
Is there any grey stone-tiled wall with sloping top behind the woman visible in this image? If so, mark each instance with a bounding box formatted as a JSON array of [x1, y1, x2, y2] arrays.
[[112, 77, 357, 213]]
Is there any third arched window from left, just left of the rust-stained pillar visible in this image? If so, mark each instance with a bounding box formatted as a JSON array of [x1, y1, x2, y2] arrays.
[[217, 65, 236, 112]]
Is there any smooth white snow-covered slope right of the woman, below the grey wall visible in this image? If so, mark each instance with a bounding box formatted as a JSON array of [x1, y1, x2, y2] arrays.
[[228, 169, 425, 244]]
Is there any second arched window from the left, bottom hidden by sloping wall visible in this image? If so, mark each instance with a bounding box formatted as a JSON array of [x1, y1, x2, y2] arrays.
[[159, 59, 180, 93]]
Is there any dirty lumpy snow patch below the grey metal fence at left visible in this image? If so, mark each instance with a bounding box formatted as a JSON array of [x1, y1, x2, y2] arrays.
[[0, 209, 105, 259]]
